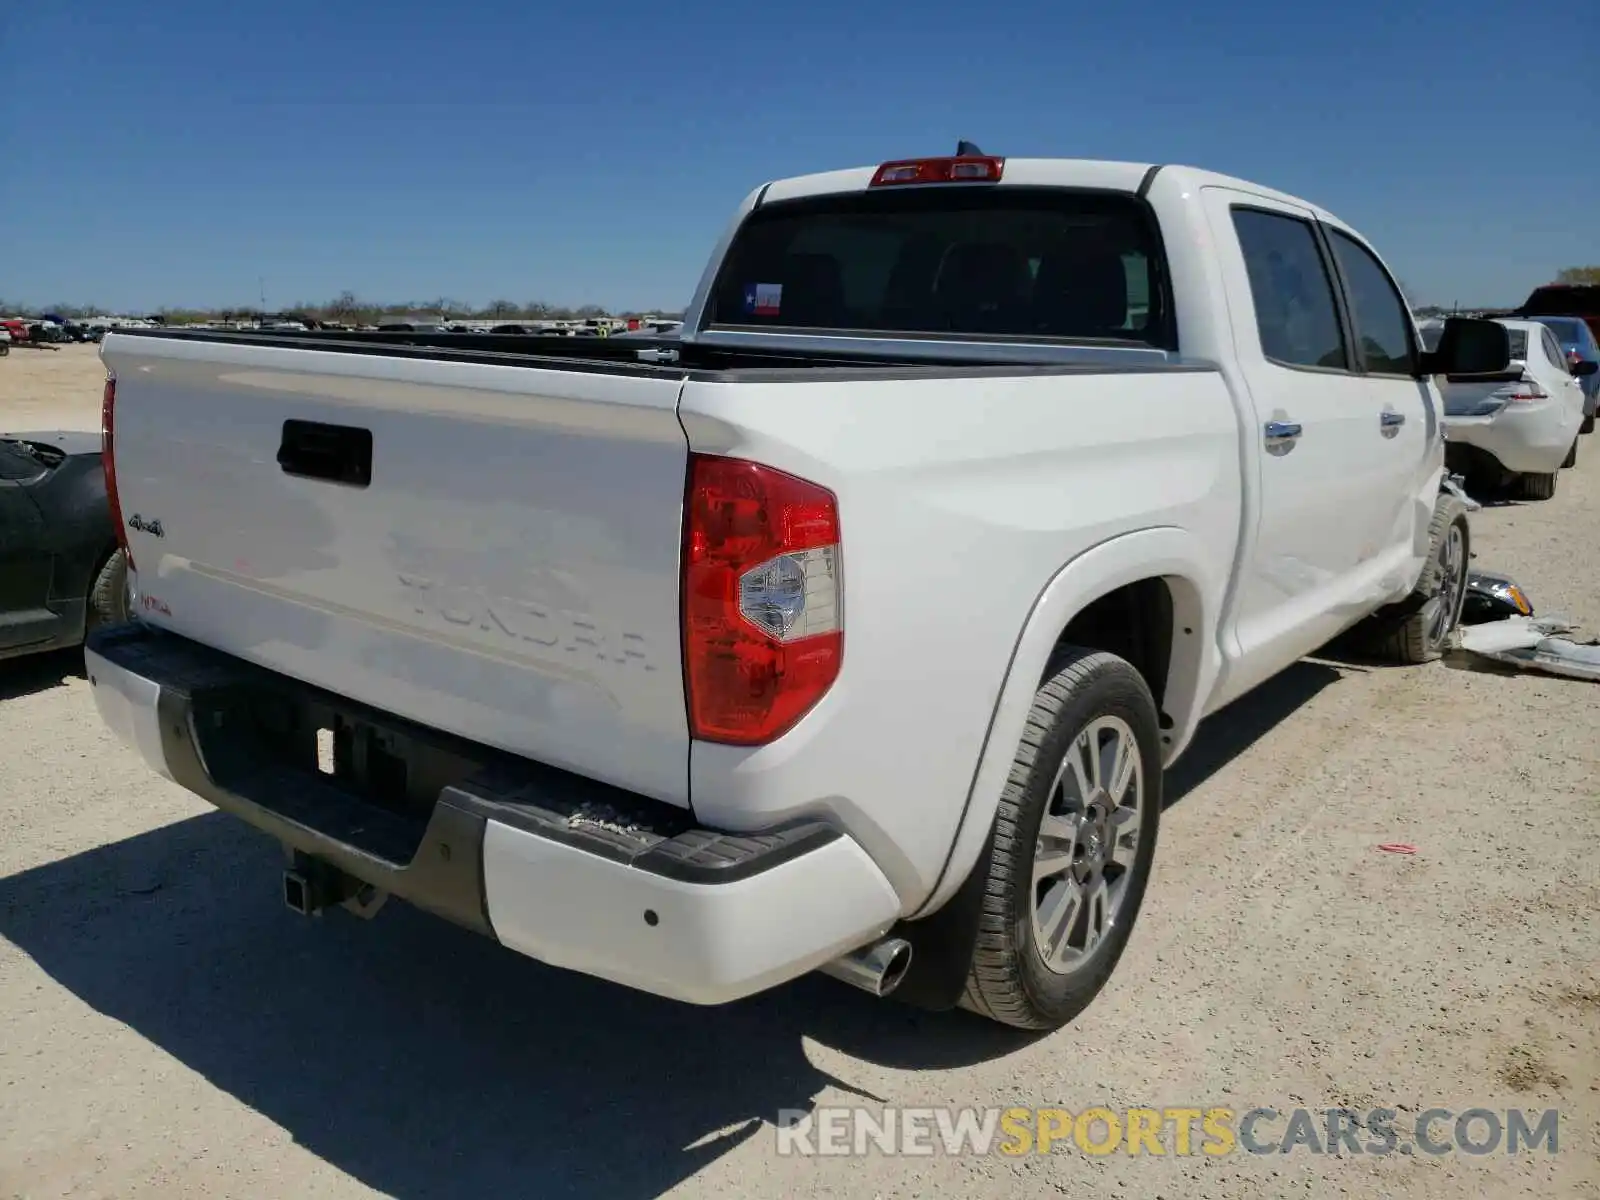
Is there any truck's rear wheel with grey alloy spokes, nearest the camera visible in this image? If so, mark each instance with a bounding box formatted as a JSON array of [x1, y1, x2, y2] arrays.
[[962, 648, 1162, 1029]]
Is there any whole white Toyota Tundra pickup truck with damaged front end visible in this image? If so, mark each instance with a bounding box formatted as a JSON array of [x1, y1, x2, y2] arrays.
[[88, 154, 1507, 1029]]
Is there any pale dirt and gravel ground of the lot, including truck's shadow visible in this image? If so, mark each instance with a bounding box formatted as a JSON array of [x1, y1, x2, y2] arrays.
[[0, 347, 1600, 1200]]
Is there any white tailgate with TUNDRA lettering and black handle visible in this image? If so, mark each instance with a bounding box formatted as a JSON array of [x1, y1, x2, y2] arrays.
[[102, 334, 688, 805]]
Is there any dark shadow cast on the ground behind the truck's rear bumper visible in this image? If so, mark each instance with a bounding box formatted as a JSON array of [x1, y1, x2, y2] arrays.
[[0, 813, 1027, 1200]]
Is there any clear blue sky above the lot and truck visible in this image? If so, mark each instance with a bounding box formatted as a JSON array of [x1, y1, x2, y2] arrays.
[[0, 0, 1600, 309]]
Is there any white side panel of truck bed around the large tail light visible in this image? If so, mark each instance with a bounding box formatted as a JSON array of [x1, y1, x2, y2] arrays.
[[680, 363, 1243, 899]]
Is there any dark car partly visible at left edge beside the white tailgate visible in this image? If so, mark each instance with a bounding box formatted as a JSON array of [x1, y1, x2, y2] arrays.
[[0, 432, 131, 659]]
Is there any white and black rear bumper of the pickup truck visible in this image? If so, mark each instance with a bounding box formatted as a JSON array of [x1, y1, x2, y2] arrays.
[[86, 626, 899, 1003]]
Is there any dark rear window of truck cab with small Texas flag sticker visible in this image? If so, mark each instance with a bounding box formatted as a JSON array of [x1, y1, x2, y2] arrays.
[[709, 187, 1176, 349]]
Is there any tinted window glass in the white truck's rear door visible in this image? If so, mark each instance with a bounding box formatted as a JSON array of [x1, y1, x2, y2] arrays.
[[1234, 208, 1349, 371]]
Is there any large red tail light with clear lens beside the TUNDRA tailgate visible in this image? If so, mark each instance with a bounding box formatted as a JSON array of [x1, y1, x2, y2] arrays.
[[683, 454, 845, 746]]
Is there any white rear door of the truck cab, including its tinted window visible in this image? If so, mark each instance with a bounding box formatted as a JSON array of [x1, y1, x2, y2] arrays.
[[1205, 187, 1394, 701]]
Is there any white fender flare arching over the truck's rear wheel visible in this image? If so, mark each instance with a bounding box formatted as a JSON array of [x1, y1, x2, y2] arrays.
[[914, 526, 1224, 918]]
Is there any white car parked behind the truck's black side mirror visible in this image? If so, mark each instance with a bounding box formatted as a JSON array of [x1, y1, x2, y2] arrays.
[[1421, 318, 1595, 499]]
